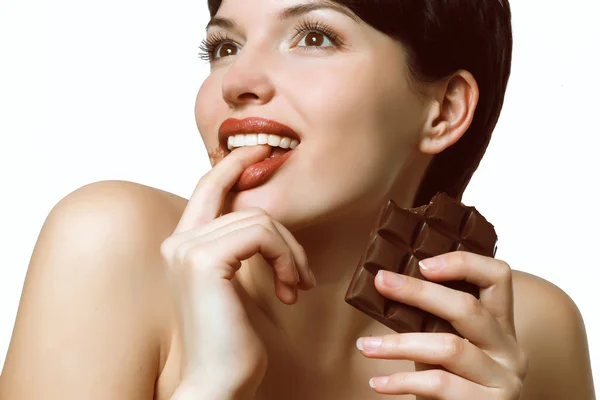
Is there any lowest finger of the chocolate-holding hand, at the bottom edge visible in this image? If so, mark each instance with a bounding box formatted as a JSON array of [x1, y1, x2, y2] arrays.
[[369, 369, 501, 400]]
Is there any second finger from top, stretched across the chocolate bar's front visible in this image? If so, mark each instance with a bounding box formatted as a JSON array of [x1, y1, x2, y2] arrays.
[[375, 270, 507, 351]]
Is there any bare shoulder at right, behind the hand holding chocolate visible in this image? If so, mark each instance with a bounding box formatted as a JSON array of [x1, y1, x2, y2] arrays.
[[513, 271, 595, 400]]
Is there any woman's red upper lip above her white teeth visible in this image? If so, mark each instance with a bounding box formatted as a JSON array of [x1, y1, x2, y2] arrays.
[[219, 117, 301, 154]]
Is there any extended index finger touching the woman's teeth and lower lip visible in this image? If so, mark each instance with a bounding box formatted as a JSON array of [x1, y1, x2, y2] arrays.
[[174, 145, 271, 233]]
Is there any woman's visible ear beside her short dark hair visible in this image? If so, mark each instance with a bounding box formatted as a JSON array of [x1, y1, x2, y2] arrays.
[[419, 70, 479, 154]]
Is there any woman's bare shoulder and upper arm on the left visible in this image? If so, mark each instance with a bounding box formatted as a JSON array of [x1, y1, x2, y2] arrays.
[[0, 181, 187, 400]]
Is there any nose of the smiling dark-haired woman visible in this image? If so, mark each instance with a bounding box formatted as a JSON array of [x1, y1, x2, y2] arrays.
[[222, 49, 275, 108]]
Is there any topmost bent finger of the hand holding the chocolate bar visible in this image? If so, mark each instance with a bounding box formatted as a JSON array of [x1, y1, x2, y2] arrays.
[[421, 251, 516, 337]]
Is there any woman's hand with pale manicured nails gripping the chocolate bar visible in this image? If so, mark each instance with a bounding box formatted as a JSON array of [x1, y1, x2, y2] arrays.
[[357, 252, 527, 400]]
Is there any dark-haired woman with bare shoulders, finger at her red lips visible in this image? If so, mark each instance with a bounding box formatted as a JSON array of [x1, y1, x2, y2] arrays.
[[0, 0, 594, 400]]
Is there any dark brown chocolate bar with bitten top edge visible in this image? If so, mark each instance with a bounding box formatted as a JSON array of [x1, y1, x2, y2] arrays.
[[345, 193, 498, 334]]
